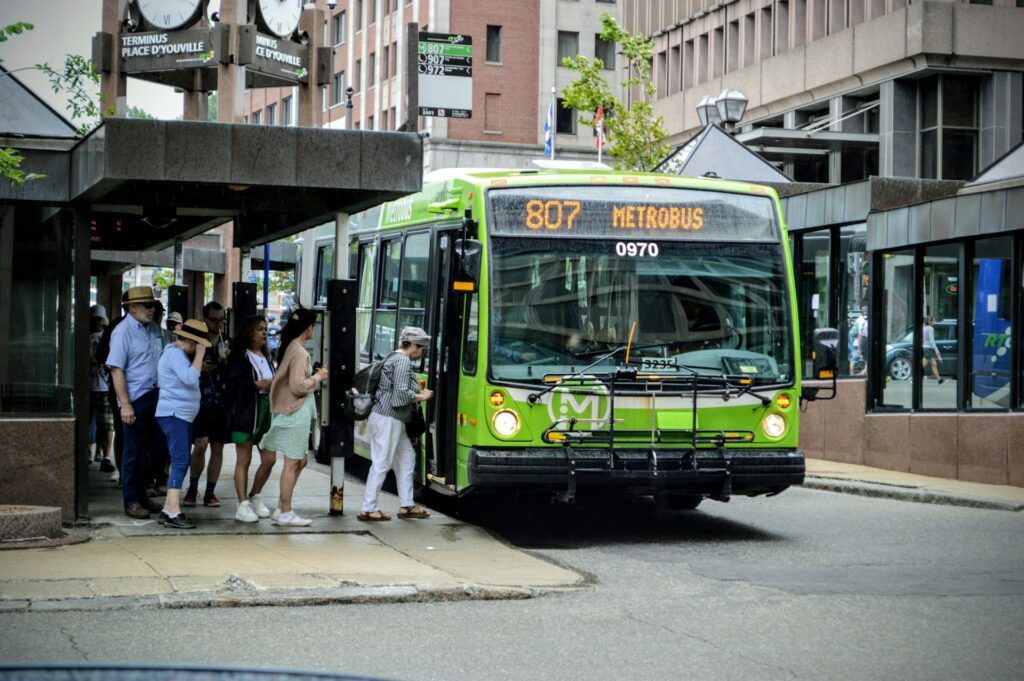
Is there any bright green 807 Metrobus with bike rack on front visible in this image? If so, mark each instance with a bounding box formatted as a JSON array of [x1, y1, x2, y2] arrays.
[[332, 163, 805, 508]]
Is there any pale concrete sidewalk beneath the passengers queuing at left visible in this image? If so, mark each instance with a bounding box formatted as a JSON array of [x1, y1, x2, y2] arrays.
[[0, 446, 586, 611]]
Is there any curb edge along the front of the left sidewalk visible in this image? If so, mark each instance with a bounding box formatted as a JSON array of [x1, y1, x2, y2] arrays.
[[0, 585, 581, 613]]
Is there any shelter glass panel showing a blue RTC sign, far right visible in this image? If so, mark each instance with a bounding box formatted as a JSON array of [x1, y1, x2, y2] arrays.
[[968, 237, 1014, 409]]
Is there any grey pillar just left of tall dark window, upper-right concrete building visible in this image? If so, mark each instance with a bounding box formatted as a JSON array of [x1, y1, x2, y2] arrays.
[[879, 80, 918, 177]]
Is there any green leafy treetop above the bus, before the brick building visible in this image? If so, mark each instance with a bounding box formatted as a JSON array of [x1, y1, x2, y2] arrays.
[[562, 12, 669, 170]]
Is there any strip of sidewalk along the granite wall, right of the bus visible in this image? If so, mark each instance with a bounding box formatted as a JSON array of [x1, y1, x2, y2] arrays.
[[804, 459, 1024, 511]]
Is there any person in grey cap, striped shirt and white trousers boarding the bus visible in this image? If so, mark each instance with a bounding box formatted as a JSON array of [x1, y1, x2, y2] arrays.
[[356, 327, 434, 521]]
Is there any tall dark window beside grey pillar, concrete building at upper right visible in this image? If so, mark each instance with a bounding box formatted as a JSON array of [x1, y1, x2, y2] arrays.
[[918, 75, 978, 180]]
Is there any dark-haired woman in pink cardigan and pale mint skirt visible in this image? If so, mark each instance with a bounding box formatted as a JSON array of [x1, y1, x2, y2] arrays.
[[259, 309, 327, 526]]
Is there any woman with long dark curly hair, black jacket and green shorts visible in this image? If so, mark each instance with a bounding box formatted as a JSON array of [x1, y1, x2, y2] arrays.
[[227, 316, 278, 522]]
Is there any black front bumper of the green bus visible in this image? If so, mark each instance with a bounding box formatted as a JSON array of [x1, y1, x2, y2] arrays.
[[468, 448, 806, 497]]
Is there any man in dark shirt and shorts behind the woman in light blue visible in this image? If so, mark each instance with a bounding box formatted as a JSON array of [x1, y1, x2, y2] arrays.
[[182, 300, 231, 507]]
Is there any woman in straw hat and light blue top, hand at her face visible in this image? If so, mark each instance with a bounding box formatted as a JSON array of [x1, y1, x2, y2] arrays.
[[157, 320, 211, 529]]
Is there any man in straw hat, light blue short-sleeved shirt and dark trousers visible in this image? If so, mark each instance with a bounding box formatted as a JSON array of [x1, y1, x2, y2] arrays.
[[106, 286, 164, 519]]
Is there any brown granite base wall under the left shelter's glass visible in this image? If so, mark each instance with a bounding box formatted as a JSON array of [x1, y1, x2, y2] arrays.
[[0, 418, 75, 521]]
